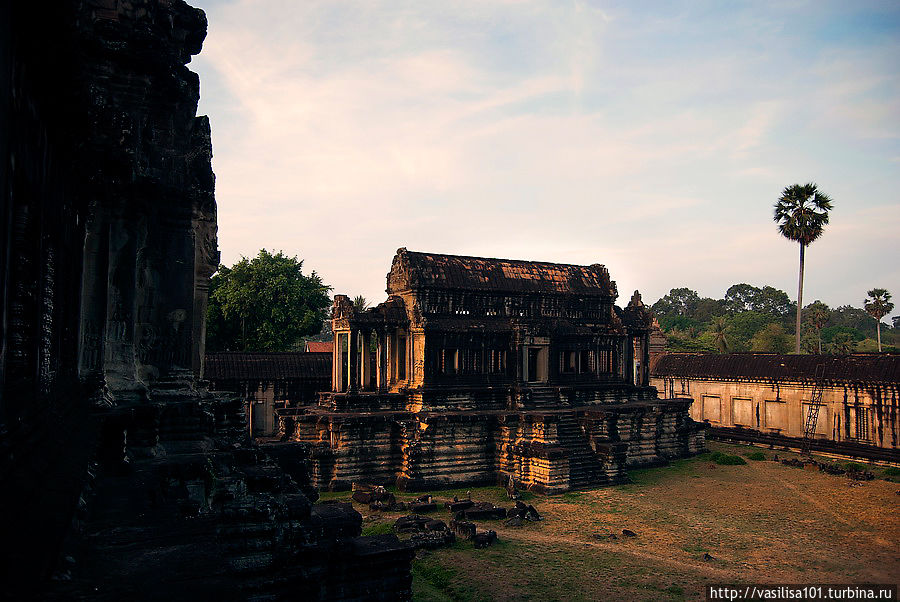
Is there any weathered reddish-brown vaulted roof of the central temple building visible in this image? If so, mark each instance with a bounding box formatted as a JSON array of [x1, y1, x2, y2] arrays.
[[388, 249, 615, 296]]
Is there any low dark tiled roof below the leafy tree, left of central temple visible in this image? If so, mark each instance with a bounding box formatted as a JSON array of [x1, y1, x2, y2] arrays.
[[204, 351, 331, 381]]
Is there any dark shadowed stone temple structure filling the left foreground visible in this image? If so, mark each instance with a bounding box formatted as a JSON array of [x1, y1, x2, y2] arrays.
[[0, 0, 413, 600]]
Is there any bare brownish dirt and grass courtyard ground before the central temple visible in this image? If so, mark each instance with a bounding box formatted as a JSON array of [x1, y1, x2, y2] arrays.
[[327, 443, 900, 600]]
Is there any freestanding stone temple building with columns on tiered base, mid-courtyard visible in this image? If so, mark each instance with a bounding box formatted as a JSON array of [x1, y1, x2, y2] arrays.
[[280, 248, 704, 493]]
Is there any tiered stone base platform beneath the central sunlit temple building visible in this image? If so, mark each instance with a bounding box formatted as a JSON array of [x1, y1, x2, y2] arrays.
[[280, 394, 705, 493]]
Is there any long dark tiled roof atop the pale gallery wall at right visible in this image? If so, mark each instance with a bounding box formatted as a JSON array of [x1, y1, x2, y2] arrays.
[[650, 353, 900, 384]]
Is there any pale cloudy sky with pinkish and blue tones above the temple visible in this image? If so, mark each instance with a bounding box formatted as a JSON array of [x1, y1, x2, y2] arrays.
[[189, 0, 900, 314]]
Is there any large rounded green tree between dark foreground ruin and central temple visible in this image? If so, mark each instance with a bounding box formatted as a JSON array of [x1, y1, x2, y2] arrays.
[[207, 249, 331, 351]]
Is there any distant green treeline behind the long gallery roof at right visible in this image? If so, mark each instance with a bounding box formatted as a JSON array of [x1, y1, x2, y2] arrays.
[[653, 284, 900, 353]]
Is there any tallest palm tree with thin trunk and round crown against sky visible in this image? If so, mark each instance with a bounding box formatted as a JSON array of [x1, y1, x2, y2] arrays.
[[775, 183, 832, 353]]
